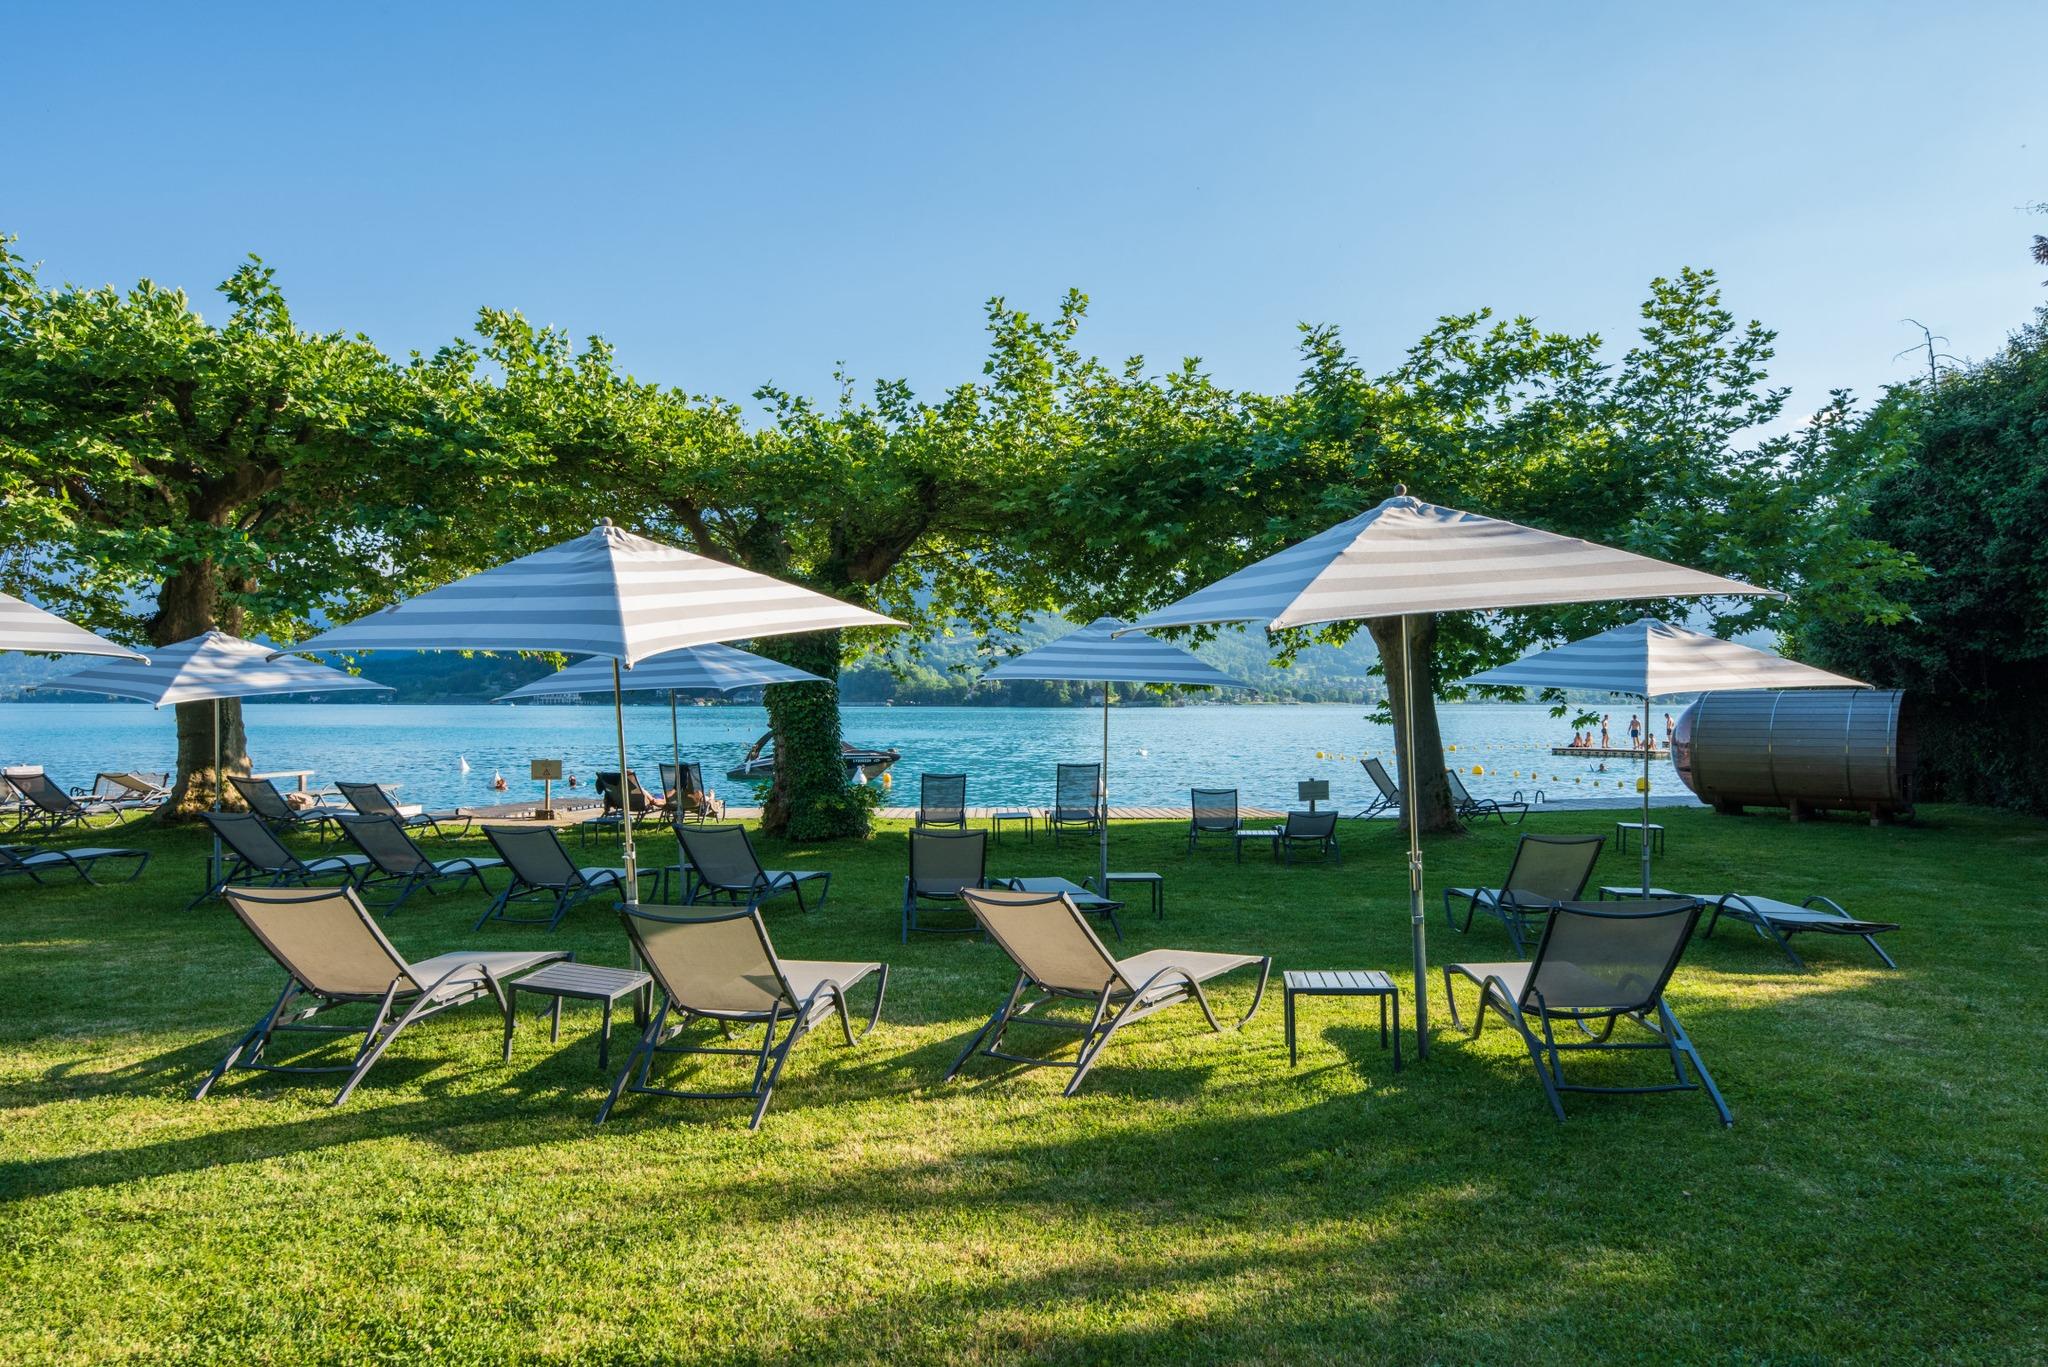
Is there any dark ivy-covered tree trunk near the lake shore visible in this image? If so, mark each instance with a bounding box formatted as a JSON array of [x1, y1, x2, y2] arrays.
[[754, 631, 874, 840]]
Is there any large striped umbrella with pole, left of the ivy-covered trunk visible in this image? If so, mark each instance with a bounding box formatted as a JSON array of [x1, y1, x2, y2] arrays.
[[291, 519, 903, 900]]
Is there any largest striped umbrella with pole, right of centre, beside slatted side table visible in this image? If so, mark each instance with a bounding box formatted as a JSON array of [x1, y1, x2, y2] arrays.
[[1135, 490, 1772, 1055]]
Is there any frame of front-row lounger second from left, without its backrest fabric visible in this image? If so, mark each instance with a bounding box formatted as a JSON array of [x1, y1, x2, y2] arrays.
[[592, 906, 889, 1129]]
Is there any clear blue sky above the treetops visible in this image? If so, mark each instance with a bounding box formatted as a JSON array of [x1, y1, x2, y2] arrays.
[[16, 0, 2048, 420]]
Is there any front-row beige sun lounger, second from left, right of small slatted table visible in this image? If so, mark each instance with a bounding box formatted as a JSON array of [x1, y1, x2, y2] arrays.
[[596, 906, 889, 1129]]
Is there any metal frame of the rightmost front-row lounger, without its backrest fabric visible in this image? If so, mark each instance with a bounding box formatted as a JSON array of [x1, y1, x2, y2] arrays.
[[1444, 898, 1735, 1125]]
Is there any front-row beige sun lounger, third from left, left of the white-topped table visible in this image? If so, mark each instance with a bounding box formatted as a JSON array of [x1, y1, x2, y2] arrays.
[[946, 889, 1274, 1096]]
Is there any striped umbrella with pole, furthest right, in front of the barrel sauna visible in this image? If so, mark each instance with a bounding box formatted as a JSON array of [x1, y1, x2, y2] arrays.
[[1462, 617, 1870, 900]]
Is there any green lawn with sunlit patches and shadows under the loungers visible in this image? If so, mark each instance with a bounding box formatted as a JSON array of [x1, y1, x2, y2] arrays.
[[0, 810, 2048, 1363]]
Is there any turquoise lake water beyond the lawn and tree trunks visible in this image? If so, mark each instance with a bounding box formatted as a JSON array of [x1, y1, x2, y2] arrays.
[[0, 703, 1686, 812]]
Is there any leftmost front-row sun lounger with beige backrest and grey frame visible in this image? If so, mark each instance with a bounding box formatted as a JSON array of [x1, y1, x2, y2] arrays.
[[193, 887, 569, 1107]]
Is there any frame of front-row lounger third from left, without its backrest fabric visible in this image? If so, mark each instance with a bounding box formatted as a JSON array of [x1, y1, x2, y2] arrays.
[[944, 892, 1274, 1096]]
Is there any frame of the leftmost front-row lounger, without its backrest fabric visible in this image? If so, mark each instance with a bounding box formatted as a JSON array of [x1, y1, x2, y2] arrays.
[[193, 887, 575, 1107]]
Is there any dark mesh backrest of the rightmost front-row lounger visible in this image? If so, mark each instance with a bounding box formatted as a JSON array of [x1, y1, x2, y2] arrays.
[[1522, 898, 1700, 1014]]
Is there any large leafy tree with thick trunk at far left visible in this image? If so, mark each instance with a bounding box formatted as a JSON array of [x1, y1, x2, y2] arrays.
[[0, 240, 493, 812]]
